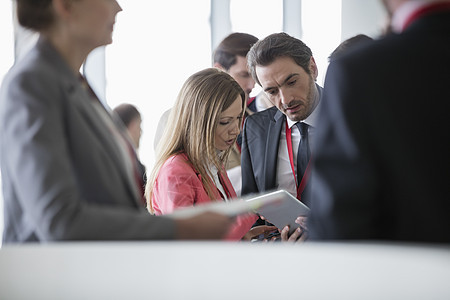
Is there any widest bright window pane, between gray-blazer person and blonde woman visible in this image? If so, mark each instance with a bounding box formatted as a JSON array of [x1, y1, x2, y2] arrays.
[[105, 0, 211, 168]]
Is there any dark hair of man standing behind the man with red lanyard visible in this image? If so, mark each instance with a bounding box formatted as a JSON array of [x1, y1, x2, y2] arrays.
[[213, 32, 258, 71]]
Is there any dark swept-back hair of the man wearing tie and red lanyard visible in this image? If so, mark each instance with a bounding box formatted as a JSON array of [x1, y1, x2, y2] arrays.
[[247, 32, 312, 85]]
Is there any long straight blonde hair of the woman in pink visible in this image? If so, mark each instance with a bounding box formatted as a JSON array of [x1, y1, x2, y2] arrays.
[[145, 68, 246, 213]]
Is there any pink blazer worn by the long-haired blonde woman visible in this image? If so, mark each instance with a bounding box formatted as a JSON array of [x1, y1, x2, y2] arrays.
[[152, 154, 257, 240]]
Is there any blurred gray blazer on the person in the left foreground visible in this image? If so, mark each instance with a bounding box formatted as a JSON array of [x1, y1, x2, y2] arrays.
[[0, 37, 175, 244]]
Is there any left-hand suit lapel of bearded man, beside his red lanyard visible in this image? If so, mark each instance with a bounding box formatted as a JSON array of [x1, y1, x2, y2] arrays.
[[264, 109, 285, 190]]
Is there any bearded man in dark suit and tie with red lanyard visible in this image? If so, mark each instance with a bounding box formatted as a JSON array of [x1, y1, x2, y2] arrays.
[[241, 33, 322, 209]]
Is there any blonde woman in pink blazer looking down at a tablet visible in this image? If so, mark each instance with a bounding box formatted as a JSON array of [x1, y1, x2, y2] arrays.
[[146, 68, 273, 240]]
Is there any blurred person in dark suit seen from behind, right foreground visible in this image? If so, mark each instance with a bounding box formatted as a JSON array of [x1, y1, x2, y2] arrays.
[[308, 0, 450, 243]]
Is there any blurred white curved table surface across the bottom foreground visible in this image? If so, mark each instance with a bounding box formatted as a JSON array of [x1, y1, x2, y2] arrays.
[[0, 242, 450, 300]]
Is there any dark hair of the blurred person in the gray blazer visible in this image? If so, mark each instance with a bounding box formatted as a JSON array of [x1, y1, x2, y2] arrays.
[[17, 0, 55, 31]]
